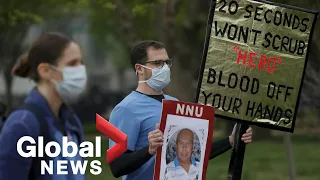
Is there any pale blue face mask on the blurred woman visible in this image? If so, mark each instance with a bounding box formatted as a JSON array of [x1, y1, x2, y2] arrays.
[[52, 65, 87, 103]]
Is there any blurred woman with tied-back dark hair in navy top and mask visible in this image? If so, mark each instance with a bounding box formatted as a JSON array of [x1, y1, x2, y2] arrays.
[[0, 33, 87, 180]]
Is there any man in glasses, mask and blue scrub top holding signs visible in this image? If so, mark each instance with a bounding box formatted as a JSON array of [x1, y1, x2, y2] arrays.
[[109, 41, 252, 180]]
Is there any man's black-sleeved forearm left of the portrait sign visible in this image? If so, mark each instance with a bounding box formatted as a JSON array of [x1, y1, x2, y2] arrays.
[[110, 146, 152, 178]]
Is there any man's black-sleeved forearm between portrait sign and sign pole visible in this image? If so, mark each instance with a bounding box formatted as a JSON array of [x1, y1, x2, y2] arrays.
[[209, 137, 232, 160]]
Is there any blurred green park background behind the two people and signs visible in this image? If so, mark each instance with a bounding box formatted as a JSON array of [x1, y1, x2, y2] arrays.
[[0, 0, 320, 180]]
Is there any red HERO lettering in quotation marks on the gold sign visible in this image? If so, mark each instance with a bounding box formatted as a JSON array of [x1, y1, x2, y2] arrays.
[[233, 46, 282, 74]]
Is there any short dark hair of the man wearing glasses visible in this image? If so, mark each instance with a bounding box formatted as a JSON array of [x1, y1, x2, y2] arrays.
[[130, 40, 165, 70]]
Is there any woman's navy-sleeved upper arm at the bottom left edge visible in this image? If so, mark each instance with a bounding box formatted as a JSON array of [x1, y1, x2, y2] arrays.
[[0, 111, 39, 180]]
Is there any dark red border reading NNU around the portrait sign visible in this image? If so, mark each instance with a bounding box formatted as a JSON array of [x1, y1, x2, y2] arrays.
[[153, 100, 214, 180]]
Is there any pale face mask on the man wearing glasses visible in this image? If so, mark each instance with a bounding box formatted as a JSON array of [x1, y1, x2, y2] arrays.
[[139, 64, 170, 91]]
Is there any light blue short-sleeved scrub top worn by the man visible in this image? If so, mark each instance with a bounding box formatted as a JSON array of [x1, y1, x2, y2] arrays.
[[109, 91, 177, 180]]
